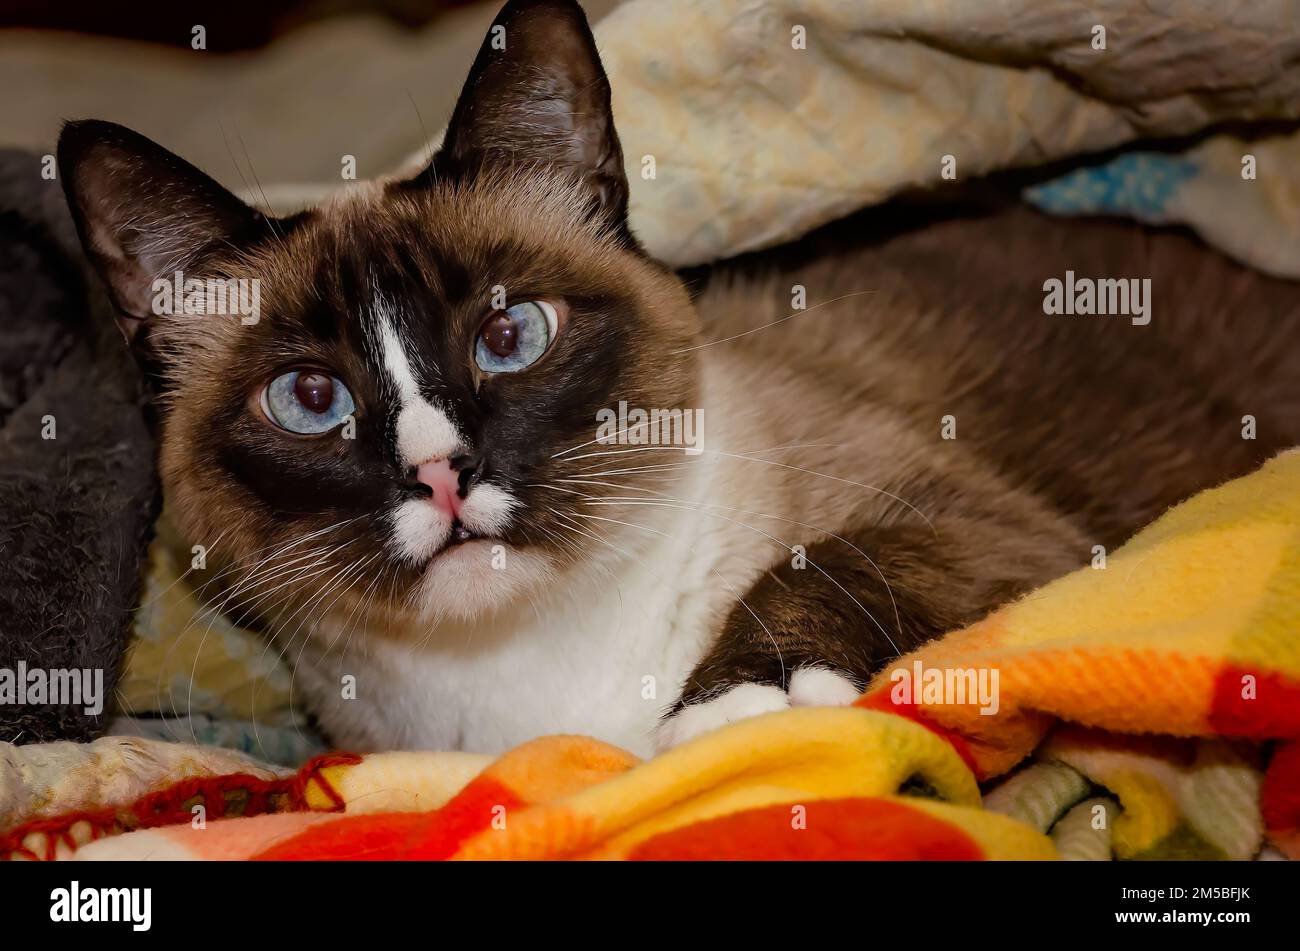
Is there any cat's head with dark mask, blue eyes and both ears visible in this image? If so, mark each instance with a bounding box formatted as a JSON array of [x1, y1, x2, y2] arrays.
[[59, 0, 696, 639]]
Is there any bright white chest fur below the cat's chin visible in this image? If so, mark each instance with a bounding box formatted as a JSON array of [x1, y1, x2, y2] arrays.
[[298, 491, 770, 755]]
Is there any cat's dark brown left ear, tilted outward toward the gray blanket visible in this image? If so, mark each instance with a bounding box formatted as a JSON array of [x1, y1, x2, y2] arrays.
[[59, 120, 269, 342]]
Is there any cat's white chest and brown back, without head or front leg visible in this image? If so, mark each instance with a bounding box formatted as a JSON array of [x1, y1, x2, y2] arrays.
[[298, 202, 1300, 751]]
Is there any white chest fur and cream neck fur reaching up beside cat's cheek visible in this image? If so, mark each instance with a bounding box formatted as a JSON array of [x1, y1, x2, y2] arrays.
[[298, 355, 816, 755]]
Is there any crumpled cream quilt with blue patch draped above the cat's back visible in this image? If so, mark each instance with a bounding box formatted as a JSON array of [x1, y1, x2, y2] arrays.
[[332, 0, 1300, 278]]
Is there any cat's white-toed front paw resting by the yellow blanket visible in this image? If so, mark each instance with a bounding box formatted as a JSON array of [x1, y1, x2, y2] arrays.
[[655, 666, 862, 752]]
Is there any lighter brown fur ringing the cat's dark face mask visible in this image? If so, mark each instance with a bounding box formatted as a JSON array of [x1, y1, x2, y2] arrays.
[[156, 170, 698, 637]]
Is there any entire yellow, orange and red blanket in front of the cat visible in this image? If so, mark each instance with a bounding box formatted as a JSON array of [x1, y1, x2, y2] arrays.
[[0, 451, 1300, 859]]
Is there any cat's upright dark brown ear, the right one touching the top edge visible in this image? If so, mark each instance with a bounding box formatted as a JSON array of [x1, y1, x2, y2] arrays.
[[426, 0, 628, 227]]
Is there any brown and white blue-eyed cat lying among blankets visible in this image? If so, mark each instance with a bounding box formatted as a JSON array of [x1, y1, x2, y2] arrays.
[[59, 0, 1300, 755]]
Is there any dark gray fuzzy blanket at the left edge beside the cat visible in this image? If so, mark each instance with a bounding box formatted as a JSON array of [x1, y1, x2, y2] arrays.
[[0, 151, 159, 743]]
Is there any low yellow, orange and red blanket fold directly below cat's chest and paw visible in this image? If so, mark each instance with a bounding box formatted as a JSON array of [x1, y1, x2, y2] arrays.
[[48, 708, 1054, 860]]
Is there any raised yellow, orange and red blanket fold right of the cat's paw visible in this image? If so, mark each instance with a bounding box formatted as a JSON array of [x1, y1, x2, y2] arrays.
[[861, 451, 1300, 859]]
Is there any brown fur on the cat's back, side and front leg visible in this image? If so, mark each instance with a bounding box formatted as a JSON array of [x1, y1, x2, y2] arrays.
[[684, 200, 1300, 702]]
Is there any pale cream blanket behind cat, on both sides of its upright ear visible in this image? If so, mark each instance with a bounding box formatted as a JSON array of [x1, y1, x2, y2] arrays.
[[0, 0, 1300, 272]]
